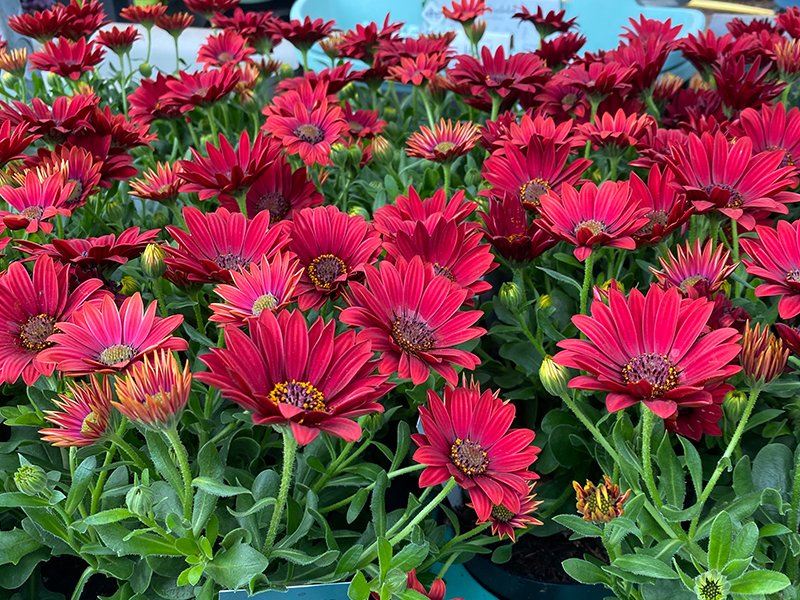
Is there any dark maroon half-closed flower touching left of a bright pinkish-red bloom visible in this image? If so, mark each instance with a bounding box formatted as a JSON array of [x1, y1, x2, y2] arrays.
[[480, 195, 558, 262]]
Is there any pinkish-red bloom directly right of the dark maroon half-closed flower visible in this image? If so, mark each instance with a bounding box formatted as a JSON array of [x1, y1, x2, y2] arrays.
[[534, 181, 648, 261]]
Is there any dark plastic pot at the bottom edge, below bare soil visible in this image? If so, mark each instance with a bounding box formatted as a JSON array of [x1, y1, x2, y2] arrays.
[[464, 556, 609, 600]]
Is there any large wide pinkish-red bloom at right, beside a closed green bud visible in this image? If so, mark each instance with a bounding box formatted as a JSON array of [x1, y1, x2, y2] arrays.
[[553, 286, 740, 418]]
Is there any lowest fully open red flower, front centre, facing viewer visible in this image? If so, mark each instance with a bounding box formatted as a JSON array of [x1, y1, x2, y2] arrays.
[[411, 386, 539, 521]]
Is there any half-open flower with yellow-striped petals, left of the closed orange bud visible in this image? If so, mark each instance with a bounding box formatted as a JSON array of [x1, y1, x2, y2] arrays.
[[39, 377, 113, 447]]
